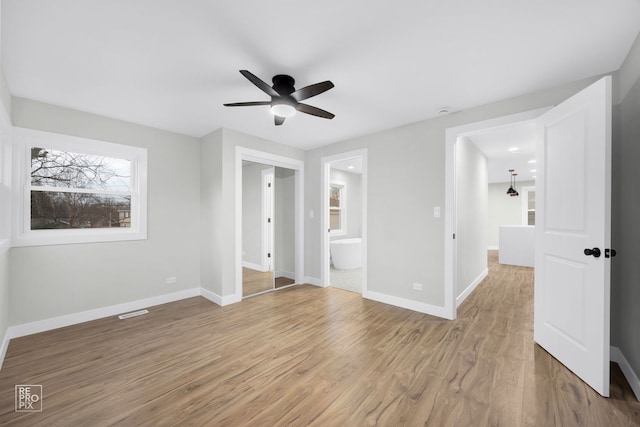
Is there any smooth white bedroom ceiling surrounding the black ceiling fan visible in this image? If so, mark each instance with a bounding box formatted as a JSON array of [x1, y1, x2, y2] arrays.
[[1, 0, 640, 149]]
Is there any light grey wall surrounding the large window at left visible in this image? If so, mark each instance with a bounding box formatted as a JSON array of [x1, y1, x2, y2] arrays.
[[9, 98, 200, 325]]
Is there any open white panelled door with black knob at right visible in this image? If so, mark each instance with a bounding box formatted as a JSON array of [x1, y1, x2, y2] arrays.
[[534, 77, 611, 396]]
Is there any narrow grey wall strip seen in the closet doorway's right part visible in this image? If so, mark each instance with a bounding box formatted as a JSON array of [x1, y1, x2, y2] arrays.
[[273, 167, 296, 279]]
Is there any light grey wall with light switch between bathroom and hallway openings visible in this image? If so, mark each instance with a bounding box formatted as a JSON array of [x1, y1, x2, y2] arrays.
[[305, 72, 616, 311]]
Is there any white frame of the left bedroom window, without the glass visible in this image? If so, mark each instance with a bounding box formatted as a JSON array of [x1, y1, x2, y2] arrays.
[[12, 128, 147, 246]]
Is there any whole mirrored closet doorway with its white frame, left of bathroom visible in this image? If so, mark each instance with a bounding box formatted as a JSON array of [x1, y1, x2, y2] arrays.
[[235, 147, 304, 299]]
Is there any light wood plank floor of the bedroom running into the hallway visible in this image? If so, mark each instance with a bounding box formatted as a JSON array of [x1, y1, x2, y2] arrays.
[[0, 254, 640, 427]]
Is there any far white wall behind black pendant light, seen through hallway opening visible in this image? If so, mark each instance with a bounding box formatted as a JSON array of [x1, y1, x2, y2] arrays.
[[488, 181, 535, 249]]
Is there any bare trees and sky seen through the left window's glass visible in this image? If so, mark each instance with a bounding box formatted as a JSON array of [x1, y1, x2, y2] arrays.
[[31, 147, 131, 230]]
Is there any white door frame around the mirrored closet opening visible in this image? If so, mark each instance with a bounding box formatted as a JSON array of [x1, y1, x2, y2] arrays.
[[234, 146, 304, 301]]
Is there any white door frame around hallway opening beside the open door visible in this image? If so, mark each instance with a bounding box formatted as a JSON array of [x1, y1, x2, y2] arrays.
[[443, 106, 552, 320]]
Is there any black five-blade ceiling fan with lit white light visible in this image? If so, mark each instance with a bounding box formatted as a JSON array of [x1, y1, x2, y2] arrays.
[[224, 70, 335, 126]]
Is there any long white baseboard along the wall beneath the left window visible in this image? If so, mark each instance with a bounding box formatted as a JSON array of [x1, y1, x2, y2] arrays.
[[8, 288, 200, 338]]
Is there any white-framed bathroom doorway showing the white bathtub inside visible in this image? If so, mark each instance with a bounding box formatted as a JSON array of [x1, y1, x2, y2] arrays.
[[321, 150, 367, 295]]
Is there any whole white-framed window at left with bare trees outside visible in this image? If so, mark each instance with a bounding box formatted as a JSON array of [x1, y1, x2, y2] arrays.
[[16, 129, 147, 246]]
